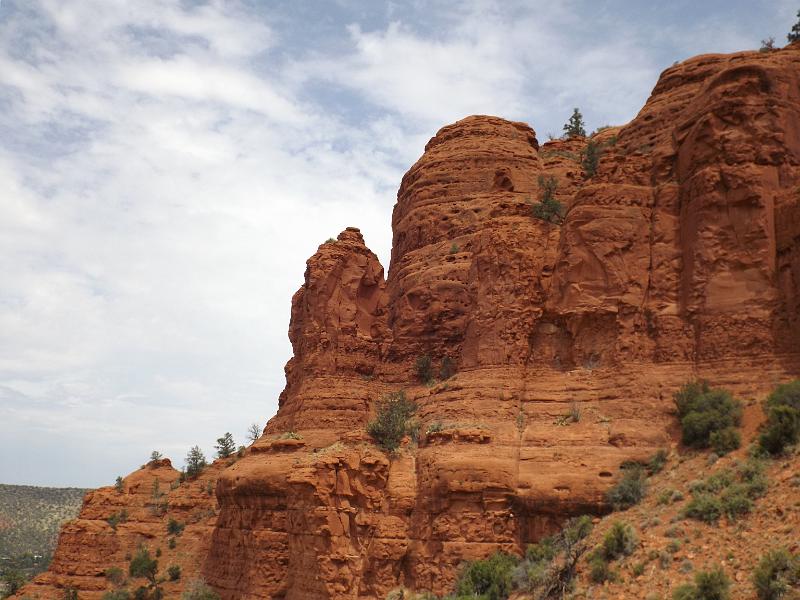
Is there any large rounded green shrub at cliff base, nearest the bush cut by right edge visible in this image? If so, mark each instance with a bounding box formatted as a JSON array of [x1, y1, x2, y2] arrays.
[[674, 381, 742, 451]]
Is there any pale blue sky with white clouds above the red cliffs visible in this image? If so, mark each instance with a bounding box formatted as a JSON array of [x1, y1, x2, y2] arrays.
[[0, 0, 800, 487]]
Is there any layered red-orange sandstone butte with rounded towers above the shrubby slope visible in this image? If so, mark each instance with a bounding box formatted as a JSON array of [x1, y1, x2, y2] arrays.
[[17, 44, 800, 600]]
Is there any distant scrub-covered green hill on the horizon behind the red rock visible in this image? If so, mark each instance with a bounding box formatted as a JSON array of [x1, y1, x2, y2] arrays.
[[0, 484, 87, 562]]
